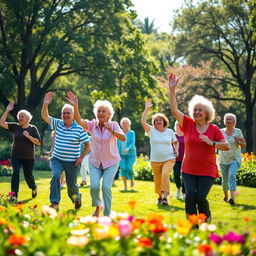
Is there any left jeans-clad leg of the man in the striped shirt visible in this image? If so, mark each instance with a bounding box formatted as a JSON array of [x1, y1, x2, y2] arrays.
[[50, 158, 64, 203]]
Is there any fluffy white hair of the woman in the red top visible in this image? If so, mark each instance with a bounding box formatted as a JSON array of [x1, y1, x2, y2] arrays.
[[188, 95, 215, 123]]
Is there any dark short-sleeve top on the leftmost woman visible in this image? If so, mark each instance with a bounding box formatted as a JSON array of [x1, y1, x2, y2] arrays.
[[7, 122, 41, 159]]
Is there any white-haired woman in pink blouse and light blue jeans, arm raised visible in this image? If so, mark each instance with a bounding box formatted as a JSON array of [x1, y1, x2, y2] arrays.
[[67, 92, 126, 216]]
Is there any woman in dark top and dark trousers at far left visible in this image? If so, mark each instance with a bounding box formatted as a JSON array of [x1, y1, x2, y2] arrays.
[[0, 102, 41, 200]]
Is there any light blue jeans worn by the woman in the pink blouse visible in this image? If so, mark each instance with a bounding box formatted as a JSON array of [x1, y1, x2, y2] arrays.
[[89, 163, 119, 216]]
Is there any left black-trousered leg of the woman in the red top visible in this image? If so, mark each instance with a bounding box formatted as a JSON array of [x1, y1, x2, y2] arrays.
[[182, 173, 197, 215]]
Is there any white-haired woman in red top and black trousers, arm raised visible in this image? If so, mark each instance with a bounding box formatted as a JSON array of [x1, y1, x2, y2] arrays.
[[169, 74, 229, 221]]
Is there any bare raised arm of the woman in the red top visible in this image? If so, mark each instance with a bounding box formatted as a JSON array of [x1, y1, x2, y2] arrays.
[[168, 74, 184, 126]]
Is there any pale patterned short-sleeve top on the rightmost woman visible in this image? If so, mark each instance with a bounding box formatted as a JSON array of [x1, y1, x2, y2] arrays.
[[218, 128, 244, 166]]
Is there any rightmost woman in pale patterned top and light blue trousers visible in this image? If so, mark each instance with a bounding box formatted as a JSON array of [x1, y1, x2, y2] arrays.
[[218, 113, 246, 205]]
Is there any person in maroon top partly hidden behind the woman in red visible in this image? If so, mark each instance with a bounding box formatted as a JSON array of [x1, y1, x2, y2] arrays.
[[173, 121, 186, 199]]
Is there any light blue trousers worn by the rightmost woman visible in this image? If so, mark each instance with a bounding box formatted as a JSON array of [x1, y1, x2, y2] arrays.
[[220, 161, 239, 191]]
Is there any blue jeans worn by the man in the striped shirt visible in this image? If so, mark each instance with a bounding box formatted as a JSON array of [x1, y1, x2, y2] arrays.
[[50, 157, 81, 203]]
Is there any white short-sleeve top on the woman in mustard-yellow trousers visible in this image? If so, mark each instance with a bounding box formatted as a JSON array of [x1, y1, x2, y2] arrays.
[[148, 126, 177, 162]]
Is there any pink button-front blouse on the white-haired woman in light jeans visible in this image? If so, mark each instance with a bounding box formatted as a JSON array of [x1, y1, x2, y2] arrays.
[[86, 119, 122, 169]]
